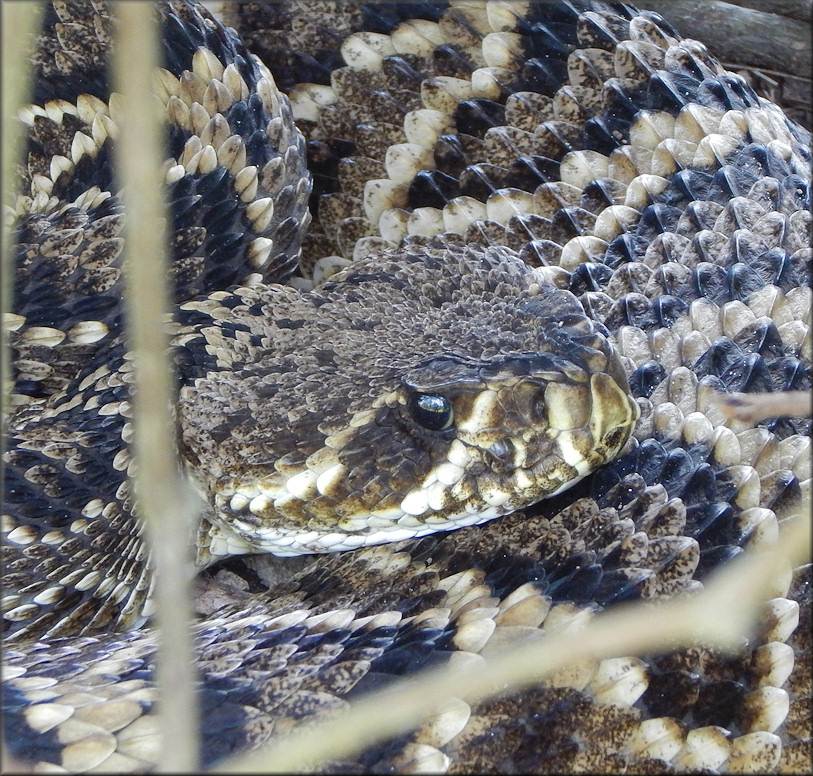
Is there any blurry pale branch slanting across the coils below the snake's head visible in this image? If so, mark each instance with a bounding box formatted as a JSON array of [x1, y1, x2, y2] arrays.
[[214, 505, 810, 773]]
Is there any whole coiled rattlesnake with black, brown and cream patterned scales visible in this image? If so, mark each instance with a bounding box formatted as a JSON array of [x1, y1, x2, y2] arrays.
[[3, 0, 811, 773]]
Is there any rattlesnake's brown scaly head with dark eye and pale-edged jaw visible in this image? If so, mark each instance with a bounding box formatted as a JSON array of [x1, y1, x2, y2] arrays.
[[181, 245, 638, 555]]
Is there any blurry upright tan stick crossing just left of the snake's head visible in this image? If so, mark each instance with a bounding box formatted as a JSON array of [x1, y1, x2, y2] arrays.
[[114, 2, 198, 772]]
